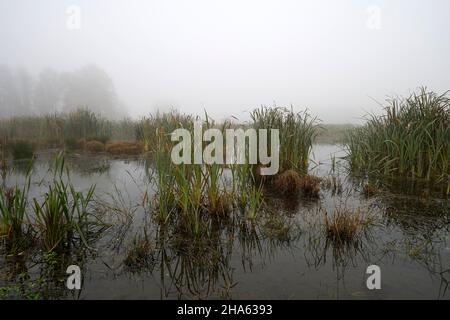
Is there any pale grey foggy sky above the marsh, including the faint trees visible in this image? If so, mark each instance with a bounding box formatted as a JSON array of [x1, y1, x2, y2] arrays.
[[0, 0, 450, 123]]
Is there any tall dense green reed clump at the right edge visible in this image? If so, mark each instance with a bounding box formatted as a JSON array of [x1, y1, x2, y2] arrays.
[[346, 88, 450, 181]]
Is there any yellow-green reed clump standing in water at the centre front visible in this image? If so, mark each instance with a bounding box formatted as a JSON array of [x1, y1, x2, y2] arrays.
[[148, 112, 236, 236]]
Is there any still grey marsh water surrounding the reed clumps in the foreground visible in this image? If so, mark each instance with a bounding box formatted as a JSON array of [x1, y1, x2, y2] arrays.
[[0, 145, 450, 299]]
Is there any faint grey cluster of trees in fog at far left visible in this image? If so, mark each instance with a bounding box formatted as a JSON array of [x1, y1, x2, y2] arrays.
[[0, 65, 126, 118]]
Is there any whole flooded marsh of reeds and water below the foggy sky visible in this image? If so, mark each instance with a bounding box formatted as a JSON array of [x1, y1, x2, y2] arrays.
[[0, 90, 450, 299]]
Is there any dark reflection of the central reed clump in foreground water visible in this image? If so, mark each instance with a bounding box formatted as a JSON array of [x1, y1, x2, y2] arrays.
[[155, 225, 236, 299]]
